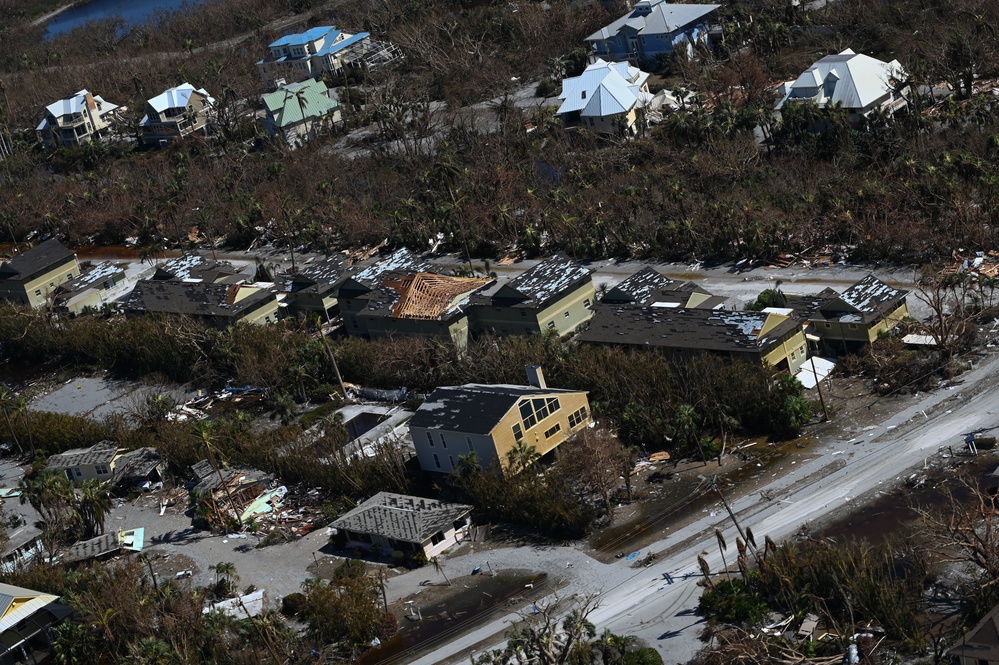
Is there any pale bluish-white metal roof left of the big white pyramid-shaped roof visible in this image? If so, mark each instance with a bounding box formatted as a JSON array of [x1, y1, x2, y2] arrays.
[[557, 58, 652, 117]]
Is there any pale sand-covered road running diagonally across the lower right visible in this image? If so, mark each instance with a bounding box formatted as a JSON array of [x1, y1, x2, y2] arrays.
[[413, 350, 999, 665]]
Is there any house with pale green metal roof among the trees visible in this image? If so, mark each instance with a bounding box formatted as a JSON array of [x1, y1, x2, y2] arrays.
[[262, 79, 340, 147]]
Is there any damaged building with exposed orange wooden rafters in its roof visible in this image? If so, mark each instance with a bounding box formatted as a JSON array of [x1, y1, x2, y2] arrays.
[[336, 249, 494, 348]]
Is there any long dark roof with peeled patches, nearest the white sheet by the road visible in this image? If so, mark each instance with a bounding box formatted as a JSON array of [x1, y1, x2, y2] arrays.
[[578, 304, 801, 353]]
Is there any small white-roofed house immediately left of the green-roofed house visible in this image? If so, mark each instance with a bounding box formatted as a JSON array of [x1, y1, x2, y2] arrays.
[[139, 83, 215, 147]]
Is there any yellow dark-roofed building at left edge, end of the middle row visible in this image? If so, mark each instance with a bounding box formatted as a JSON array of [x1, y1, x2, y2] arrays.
[[0, 238, 80, 307]]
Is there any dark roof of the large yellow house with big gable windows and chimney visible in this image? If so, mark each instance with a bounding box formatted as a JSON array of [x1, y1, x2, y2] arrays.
[[409, 383, 583, 434]]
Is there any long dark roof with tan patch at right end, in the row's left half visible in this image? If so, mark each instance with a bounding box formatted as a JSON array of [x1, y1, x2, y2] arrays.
[[124, 280, 276, 318]]
